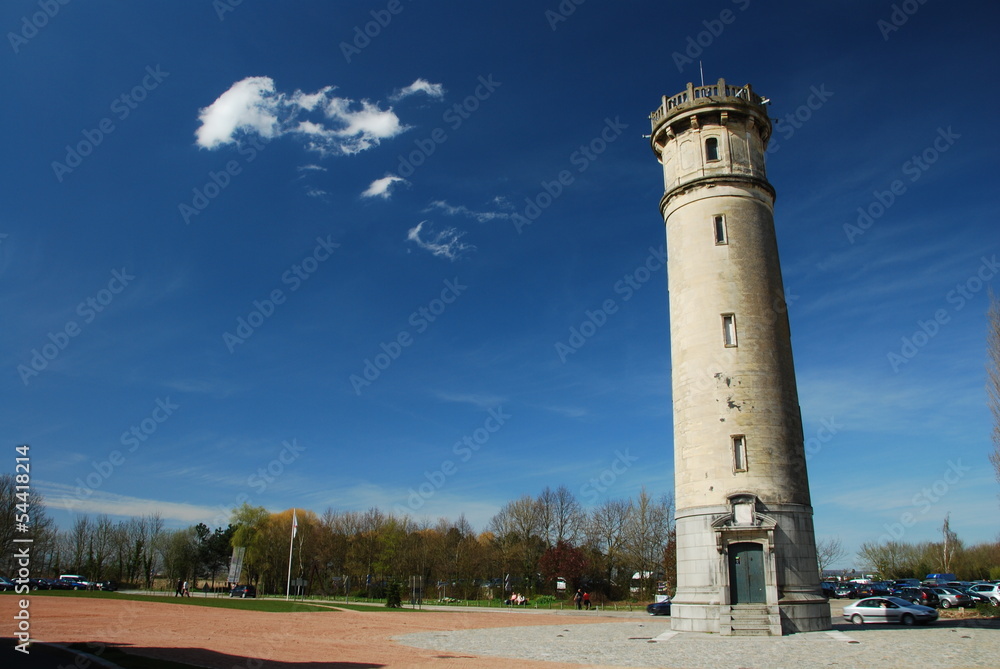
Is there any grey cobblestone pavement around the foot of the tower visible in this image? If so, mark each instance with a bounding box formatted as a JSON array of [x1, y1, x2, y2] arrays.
[[395, 618, 1000, 669]]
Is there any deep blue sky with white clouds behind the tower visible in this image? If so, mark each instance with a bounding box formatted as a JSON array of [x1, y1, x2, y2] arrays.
[[0, 0, 1000, 566]]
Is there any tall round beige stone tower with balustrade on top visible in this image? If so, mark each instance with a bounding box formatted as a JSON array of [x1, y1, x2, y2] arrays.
[[650, 79, 830, 635]]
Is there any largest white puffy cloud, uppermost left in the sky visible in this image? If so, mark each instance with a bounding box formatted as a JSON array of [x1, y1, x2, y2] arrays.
[[195, 77, 407, 155]]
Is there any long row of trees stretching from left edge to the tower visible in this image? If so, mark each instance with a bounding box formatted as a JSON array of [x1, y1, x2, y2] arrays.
[[0, 475, 675, 599]]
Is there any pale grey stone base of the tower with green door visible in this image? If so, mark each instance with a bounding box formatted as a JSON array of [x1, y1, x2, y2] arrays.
[[670, 495, 831, 636]]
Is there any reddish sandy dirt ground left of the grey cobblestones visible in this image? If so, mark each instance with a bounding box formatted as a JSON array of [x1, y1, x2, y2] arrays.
[[7, 597, 620, 669]]
